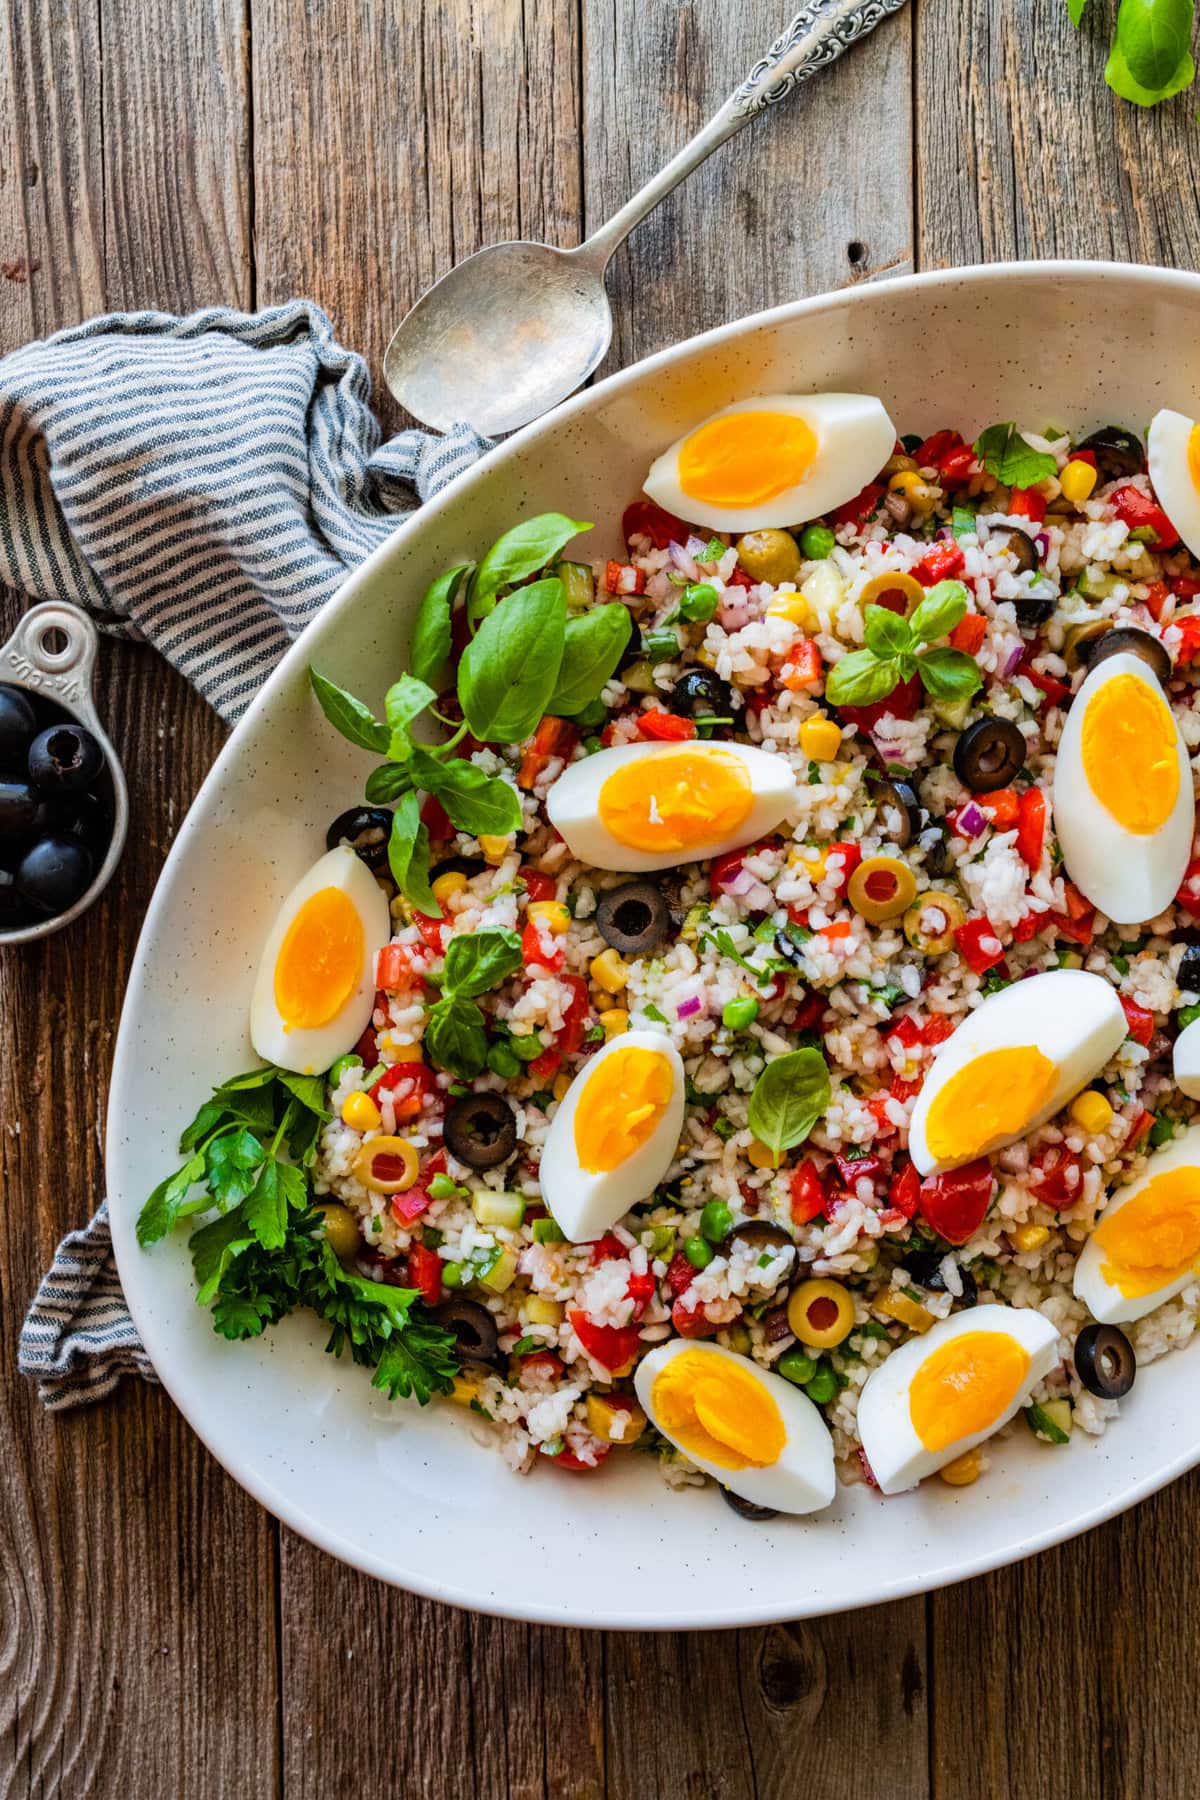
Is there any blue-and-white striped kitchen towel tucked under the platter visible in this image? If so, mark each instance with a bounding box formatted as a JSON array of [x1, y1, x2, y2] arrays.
[[9, 301, 489, 1409]]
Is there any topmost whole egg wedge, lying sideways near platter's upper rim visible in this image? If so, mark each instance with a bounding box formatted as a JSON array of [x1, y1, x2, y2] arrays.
[[646, 394, 896, 531]]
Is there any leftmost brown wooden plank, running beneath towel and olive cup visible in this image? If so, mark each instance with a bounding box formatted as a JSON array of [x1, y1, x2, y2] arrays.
[[0, 0, 277, 1796]]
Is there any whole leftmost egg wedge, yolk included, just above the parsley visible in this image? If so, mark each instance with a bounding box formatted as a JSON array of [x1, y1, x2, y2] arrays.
[[250, 844, 392, 1075]]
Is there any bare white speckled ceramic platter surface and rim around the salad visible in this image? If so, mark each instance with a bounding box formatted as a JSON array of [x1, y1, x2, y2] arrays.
[[108, 263, 1200, 1629]]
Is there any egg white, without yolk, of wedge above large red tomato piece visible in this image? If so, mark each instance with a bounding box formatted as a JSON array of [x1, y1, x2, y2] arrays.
[[909, 968, 1126, 1175]]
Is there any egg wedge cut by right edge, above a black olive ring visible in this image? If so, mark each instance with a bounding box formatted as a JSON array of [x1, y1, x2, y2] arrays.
[[1076, 1125, 1200, 1325]]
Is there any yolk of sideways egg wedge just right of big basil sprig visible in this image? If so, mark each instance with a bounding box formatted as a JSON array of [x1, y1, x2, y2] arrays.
[[599, 751, 754, 851]]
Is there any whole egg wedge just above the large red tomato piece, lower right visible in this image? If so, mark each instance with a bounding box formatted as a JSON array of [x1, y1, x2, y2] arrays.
[[909, 968, 1126, 1175]]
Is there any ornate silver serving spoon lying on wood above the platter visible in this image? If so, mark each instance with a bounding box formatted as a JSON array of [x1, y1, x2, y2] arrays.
[[383, 0, 903, 437]]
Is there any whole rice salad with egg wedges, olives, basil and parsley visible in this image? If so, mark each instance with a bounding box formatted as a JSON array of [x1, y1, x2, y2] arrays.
[[142, 396, 1200, 1517]]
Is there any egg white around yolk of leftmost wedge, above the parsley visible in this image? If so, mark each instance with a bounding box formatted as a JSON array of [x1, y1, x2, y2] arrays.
[[250, 844, 392, 1075]]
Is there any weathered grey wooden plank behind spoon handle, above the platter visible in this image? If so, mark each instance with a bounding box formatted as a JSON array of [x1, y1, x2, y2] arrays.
[[583, 0, 912, 373]]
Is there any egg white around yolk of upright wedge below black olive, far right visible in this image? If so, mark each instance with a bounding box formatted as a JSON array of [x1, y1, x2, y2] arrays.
[[1054, 652, 1196, 925]]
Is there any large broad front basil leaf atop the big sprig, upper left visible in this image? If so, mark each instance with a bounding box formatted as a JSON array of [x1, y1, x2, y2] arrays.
[[459, 576, 567, 743]]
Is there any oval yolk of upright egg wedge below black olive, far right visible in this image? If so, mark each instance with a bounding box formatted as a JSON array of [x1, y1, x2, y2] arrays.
[[1081, 673, 1178, 837]]
